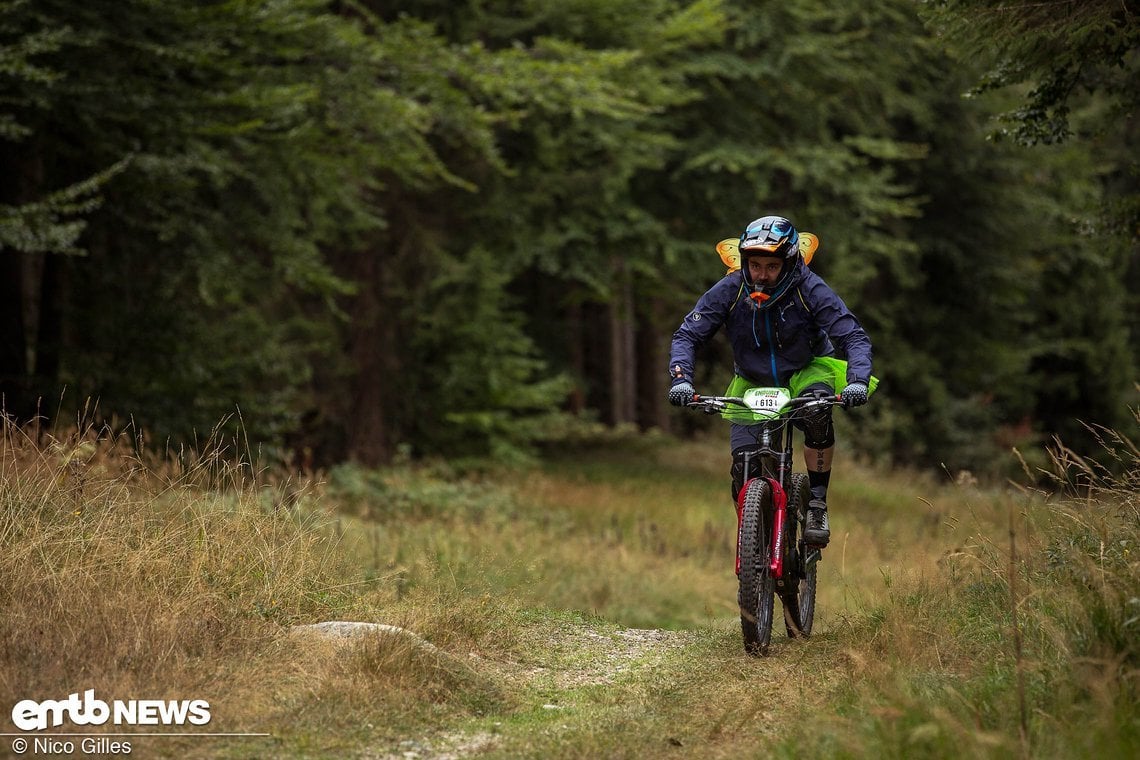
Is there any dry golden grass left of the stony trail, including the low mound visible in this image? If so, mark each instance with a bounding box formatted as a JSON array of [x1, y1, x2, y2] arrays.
[[0, 424, 517, 757]]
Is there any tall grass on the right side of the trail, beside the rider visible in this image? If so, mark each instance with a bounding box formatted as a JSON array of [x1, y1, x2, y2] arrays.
[[752, 417, 1140, 758]]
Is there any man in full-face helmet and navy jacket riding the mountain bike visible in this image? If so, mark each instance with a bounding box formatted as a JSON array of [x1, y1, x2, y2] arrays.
[[669, 216, 874, 546]]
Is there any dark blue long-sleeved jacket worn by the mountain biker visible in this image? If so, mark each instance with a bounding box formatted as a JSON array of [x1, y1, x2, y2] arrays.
[[669, 262, 871, 391]]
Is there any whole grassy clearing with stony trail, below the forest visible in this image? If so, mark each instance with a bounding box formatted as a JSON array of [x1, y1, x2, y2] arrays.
[[0, 419, 1140, 758]]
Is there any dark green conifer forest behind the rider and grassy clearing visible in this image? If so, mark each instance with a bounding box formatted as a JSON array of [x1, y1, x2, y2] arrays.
[[0, 0, 1140, 474]]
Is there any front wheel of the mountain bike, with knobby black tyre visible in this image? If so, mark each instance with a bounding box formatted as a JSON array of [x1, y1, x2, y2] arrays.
[[736, 477, 775, 656]]
